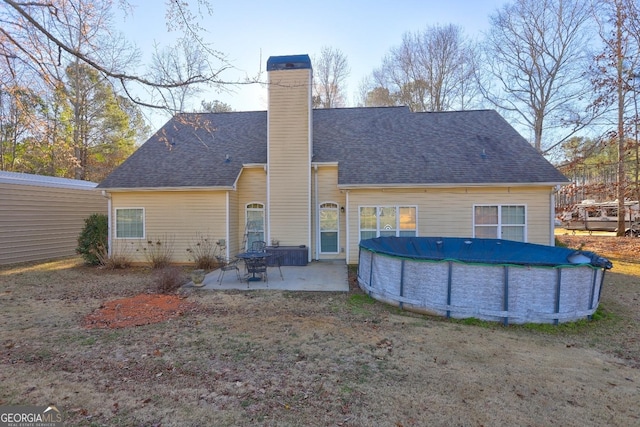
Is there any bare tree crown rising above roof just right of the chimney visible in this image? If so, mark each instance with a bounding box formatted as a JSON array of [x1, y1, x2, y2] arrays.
[[365, 25, 476, 111]]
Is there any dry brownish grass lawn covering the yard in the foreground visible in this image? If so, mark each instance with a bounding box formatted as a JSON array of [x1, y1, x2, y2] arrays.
[[0, 237, 640, 427]]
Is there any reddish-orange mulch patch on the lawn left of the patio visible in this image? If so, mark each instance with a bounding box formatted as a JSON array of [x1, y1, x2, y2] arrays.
[[82, 294, 196, 329]]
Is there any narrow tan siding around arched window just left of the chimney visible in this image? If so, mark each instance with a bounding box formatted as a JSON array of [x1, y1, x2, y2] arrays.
[[236, 168, 267, 253]]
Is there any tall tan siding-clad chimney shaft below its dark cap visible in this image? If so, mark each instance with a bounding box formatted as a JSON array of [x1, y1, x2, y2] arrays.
[[267, 69, 311, 245]]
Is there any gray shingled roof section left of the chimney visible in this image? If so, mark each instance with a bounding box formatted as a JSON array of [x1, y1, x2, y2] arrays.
[[98, 111, 267, 188]]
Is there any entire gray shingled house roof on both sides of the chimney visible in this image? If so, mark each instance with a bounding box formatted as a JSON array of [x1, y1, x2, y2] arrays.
[[98, 107, 568, 188]]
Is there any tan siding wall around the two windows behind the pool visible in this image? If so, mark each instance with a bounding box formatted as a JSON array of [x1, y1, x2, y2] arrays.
[[348, 187, 553, 263]]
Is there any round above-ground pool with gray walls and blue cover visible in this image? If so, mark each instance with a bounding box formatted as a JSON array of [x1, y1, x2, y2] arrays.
[[358, 237, 612, 324]]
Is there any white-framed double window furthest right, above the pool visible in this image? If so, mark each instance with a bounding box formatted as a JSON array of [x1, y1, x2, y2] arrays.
[[473, 205, 526, 242]]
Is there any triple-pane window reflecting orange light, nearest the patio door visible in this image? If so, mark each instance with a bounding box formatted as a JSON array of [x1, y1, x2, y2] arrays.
[[360, 206, 418, 240]]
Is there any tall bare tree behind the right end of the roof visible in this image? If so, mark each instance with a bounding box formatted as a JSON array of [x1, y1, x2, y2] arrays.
[[482, 0, 591, 152]]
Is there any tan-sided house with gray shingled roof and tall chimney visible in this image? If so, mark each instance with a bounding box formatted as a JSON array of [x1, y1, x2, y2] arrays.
[[98, 55, 568, 264]]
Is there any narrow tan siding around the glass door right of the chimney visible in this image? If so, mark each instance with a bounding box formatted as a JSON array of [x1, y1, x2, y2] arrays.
[[312, 166, 347, 260]]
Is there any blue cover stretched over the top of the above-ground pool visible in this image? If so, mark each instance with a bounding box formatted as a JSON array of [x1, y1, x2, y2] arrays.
[[360, 237, 613, 269]]
